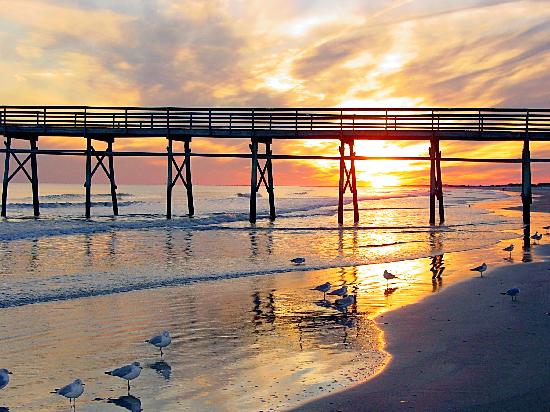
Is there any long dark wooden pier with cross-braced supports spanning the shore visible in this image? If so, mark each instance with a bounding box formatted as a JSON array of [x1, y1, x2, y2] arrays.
[[0, 106, 550, 225]]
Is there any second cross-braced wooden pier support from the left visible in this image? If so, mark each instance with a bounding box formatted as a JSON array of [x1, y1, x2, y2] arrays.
[[84, 136, 118, 219]]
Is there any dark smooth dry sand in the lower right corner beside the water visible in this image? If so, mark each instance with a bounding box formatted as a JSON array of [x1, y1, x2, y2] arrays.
[[297, 245, 550, 411]]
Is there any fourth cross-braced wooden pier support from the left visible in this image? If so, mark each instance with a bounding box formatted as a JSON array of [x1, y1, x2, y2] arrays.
[[249, 138, 276, 223]]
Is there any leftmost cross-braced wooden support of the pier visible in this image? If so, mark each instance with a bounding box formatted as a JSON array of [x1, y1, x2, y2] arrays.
[[1, 135, 40, 217]]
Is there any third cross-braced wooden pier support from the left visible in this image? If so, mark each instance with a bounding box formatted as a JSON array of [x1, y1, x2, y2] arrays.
[[166, 136, 195, 219]]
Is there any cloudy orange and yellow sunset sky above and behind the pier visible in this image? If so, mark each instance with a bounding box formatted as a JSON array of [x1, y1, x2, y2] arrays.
[[0, 0, 550, 186]]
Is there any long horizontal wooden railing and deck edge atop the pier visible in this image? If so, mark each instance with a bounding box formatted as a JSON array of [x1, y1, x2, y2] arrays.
[[0, 106, 550, 139]]
